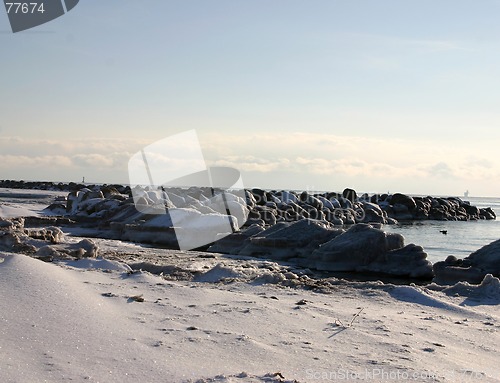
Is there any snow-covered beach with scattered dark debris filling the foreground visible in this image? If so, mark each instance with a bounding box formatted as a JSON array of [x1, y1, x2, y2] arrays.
[[0, 186, 500, 382]]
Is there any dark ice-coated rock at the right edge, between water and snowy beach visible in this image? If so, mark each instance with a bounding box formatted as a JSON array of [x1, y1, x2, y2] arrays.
[[434, 239, 500, 285]]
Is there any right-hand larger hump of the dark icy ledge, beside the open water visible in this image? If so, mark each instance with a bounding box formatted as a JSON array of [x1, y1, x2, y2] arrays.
[[310, 223, 433, 278]]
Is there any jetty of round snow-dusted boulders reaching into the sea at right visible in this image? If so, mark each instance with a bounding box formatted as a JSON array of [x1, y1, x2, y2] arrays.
[[243, 189, 496, 225]]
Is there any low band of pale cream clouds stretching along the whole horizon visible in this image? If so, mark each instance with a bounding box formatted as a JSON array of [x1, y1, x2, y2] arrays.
[[0, 132, 500, 195]]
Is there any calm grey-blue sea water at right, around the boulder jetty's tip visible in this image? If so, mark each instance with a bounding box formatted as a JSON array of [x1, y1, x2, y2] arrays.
[[383, 197, 500, 263]]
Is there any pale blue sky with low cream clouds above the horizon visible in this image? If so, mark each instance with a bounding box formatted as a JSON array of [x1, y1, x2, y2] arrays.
[[0, 0, 500, 197]]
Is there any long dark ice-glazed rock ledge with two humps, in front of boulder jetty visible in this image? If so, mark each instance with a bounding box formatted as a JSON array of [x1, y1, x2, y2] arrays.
[[208, 219, 434, 279]]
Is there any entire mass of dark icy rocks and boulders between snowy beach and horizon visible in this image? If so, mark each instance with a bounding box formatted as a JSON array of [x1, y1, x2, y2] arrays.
[[0, 183, 500, 284]]
